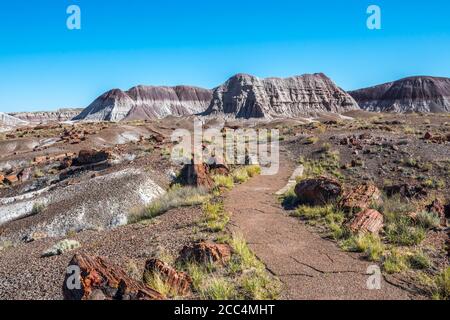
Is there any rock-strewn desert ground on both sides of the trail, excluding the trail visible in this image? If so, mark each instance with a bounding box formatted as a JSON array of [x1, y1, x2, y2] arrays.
[[0, 111, 450, 299]]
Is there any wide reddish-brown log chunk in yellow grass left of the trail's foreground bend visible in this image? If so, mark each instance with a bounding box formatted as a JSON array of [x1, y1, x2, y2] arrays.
[[180, 241, 231, 264]]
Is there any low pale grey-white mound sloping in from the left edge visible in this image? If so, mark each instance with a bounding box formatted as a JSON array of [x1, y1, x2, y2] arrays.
[[0, 168, 165, 241]]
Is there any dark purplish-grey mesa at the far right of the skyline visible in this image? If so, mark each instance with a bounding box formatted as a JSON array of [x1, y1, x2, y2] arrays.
[[349, 77, 450, 113]]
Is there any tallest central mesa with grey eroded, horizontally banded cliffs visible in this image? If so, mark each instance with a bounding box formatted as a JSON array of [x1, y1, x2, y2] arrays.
[[204, 73, 359, 119]]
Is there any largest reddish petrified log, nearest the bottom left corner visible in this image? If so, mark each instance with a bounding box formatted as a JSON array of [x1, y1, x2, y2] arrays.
[[63, 254, 165, 300]]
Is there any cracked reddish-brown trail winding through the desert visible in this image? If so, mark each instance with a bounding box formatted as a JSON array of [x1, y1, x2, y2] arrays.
[[225, 152, 420, 300]]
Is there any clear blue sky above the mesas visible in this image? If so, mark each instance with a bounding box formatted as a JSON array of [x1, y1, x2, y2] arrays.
[[0, 0, 450, 112]]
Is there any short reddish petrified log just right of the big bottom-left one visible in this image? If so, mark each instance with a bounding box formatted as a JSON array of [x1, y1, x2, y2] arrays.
[[144, 259, 192, 296]]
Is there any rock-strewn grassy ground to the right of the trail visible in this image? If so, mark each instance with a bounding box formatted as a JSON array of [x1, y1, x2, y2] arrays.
[[280, 112, 450, 299]]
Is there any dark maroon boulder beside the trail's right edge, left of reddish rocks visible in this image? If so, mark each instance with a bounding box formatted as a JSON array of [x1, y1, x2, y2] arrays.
[[295, 177, 342, 206]]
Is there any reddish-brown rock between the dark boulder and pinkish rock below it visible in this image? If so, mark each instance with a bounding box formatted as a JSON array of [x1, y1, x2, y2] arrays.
[[340, 183, 382, 212]]
